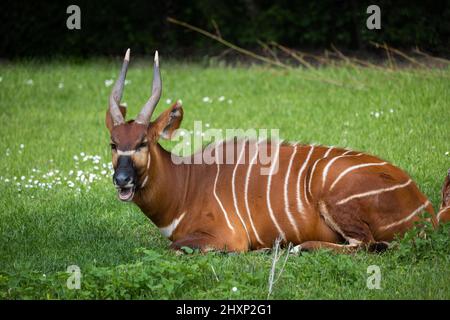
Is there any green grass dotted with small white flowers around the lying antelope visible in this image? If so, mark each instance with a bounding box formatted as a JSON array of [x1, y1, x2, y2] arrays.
[[0, 61, 450, 299]]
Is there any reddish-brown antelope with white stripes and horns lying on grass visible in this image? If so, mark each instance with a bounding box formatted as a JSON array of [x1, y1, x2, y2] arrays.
[[106, 49, 450, 252]]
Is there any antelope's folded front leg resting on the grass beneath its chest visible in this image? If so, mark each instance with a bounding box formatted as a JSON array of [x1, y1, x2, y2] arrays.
[[170, 232, 241, 252]]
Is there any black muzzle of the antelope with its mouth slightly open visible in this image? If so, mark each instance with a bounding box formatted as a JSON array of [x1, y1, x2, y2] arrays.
[[113, 156, 136, 201]]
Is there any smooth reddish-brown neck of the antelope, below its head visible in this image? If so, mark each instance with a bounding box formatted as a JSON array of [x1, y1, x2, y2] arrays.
[[134, 144, 190, 228]]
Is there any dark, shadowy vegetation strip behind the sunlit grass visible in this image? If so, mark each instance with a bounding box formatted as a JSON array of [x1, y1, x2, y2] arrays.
[[0, 0, 450, 58]]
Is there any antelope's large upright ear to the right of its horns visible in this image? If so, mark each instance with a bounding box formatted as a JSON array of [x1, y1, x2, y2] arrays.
[[149, 101, 183, 140]]
